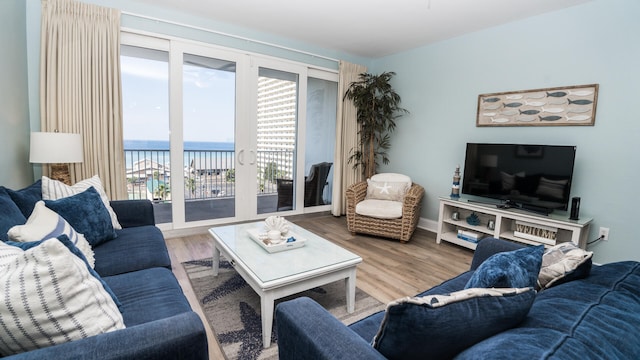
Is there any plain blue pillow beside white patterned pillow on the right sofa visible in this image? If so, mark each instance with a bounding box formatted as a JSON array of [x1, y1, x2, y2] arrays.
[[464, 245, 544, 289]]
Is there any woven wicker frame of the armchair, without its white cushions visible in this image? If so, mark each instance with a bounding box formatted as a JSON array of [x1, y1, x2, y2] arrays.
[[346, 176, 424, 243]]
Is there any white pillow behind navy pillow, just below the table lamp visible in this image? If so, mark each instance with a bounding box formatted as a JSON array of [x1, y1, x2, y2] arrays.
[[42, 175, 122, 229]]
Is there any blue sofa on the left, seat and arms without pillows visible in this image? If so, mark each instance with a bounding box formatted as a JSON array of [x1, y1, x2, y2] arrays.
[[0, 184, 208, 360]]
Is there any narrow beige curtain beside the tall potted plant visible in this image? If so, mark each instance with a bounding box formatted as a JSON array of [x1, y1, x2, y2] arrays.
[[331, 61, 367, 216]]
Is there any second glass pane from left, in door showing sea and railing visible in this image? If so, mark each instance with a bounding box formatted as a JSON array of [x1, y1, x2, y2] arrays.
[[182, 53, 236, 222]]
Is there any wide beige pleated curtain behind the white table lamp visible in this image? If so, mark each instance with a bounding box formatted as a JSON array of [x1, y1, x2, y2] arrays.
[[40, 0, 127, 199]]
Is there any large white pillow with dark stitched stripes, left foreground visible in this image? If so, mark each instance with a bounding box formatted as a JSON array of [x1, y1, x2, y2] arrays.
[[0, 238, 125, 356]]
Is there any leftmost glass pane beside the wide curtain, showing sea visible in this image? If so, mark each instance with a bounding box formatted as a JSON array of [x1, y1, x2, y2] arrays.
[[120, 45, 171, 223]]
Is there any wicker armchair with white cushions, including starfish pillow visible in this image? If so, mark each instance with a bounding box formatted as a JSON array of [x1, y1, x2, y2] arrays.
[[346, 173, 424, 243]]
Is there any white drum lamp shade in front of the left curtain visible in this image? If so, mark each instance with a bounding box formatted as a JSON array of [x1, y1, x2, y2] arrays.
[[29, 132, 83, 164]]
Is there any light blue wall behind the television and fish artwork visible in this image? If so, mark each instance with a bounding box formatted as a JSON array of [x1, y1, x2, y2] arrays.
[[370, 0, 640, 262]]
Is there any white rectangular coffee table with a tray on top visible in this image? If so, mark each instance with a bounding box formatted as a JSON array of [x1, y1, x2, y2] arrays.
[[209, 221, 362, 348]]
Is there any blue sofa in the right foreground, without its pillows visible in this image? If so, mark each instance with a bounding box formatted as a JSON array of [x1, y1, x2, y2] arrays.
[[276, 239, 640, 360]]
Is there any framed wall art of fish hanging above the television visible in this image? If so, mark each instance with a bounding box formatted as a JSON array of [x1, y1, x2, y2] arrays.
[[476, 84, 598, 126]]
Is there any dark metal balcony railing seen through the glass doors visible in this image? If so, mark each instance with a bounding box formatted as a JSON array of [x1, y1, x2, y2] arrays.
[[124, 149, 294, 202]]
